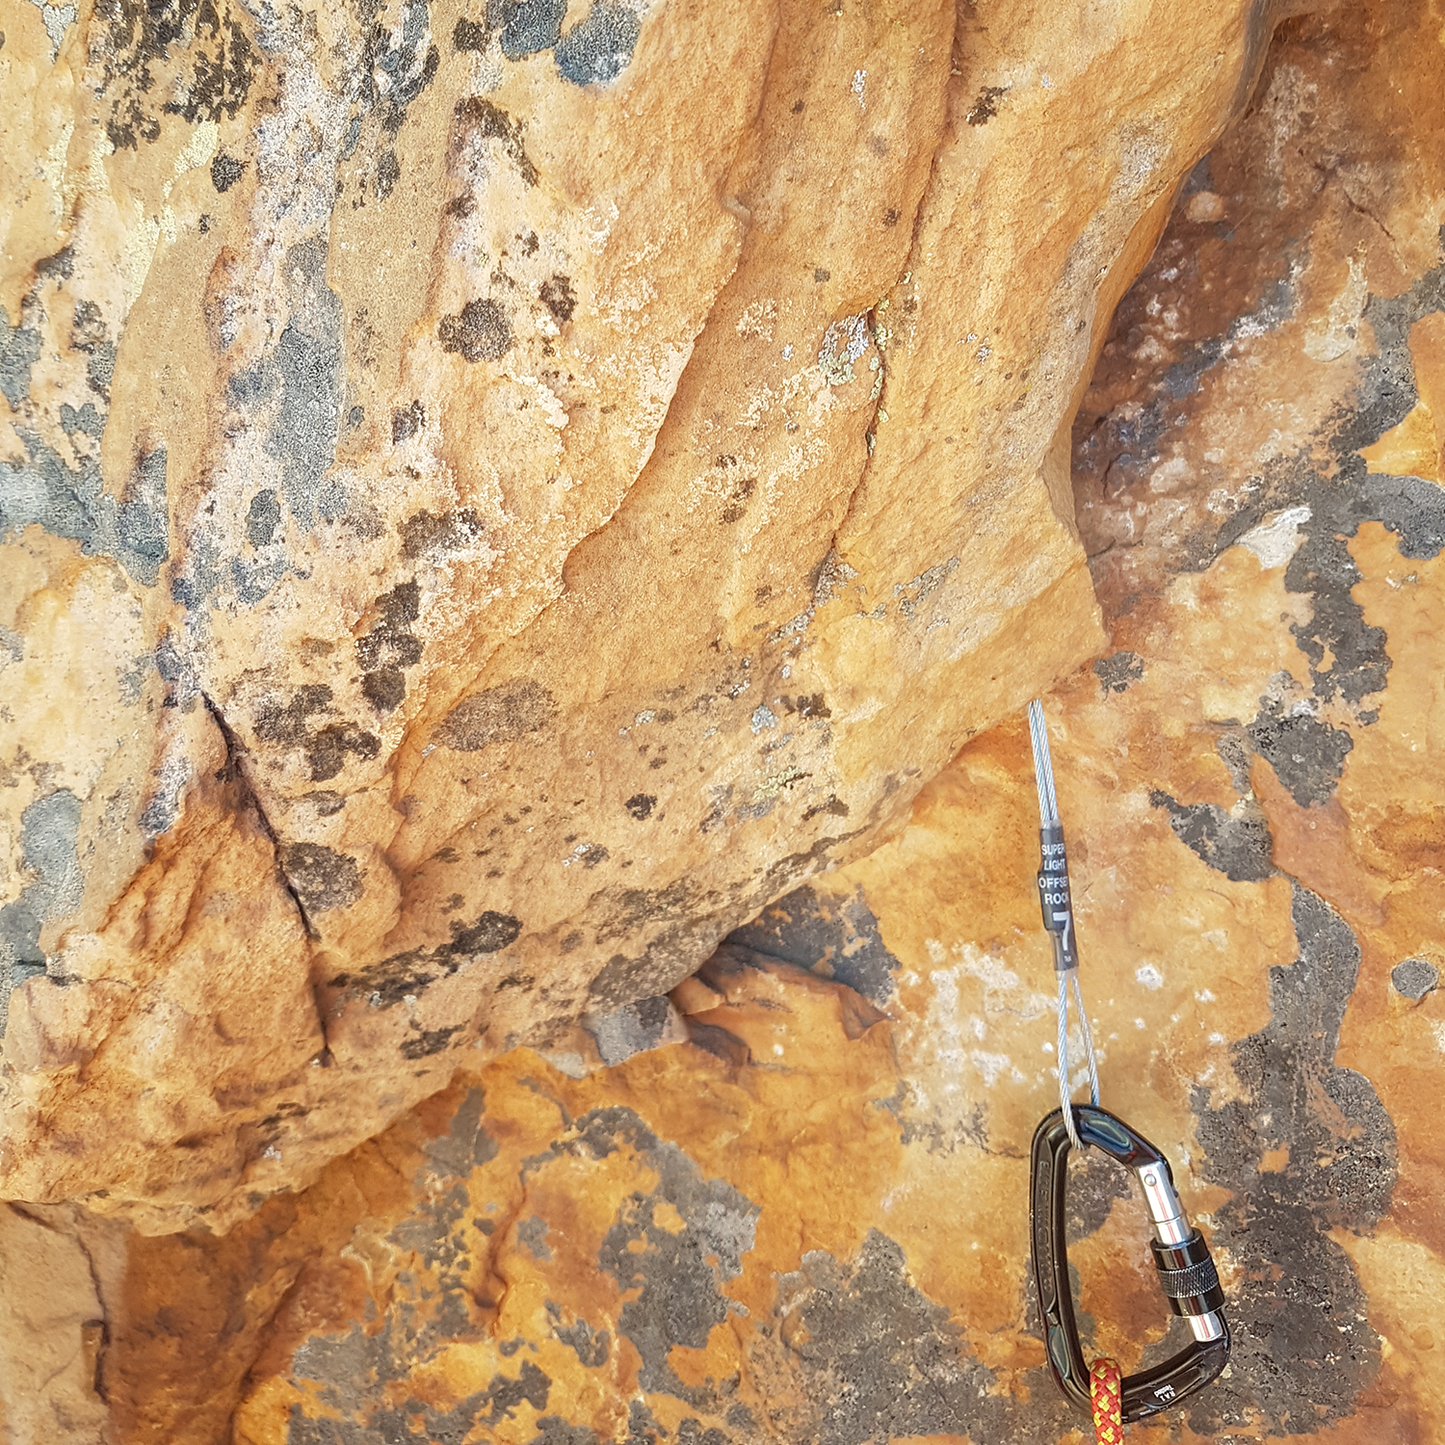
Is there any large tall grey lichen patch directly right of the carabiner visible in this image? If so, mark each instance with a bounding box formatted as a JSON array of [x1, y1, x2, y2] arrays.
[[1189, 884, 1396, 1435]]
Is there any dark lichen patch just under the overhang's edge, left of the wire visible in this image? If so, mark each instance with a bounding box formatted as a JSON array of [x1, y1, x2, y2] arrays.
[[724, 884, 899, 1004]]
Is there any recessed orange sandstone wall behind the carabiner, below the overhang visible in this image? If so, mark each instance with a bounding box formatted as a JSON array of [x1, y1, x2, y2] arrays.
[[0, 4, 1445, 1445]]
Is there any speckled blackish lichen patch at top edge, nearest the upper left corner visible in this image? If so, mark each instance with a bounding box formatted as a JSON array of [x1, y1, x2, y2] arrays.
[[98, 0, 260, 150]]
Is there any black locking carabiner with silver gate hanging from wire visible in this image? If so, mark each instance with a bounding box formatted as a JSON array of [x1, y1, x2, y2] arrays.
[[1029, 1104, 1230, 1420]]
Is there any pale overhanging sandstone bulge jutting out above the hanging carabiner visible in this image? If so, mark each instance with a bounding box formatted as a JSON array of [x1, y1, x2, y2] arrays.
[[0, 0, 1300, 1231]]
